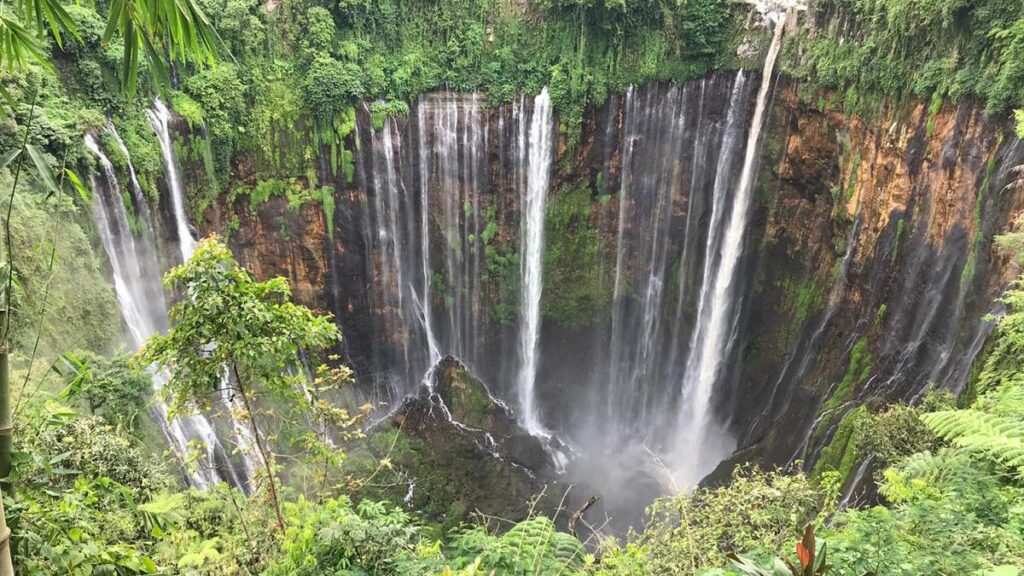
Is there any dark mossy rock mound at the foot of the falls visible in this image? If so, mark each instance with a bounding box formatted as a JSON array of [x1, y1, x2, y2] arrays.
[[366, 357, 567, 524]]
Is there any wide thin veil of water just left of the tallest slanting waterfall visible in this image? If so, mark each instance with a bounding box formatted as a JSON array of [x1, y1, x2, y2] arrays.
[[585, 75, 750, 460]]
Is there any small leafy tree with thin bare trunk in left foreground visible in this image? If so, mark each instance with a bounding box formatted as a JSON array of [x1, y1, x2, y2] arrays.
[[139, 237, 340, 529]]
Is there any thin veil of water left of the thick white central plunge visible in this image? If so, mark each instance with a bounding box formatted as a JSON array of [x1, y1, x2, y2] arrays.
[[356, 91, 487, 405]]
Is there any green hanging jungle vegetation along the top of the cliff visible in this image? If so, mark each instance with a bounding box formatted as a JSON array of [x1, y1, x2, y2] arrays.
[[8, 0, 1024, 215]]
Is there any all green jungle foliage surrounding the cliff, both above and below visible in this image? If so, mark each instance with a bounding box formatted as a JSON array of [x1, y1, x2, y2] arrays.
[[6, 0, 1024, 576]]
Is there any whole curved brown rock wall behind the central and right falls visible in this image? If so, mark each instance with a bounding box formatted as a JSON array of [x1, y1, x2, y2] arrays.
[[190, 75, 1024, 481]]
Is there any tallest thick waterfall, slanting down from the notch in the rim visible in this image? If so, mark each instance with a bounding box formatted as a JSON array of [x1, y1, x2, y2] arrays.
[[676, 15, 786, 485]]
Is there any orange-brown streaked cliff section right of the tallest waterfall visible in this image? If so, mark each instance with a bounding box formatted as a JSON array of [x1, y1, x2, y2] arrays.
[[736, 86, 1022, 463]]
